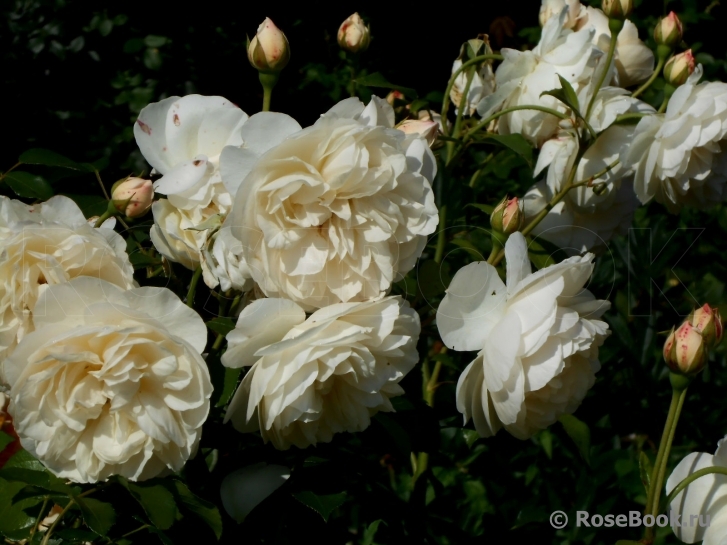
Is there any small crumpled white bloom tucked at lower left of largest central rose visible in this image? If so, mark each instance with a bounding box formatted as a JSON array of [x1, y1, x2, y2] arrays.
[[202, 226, 253, 291]]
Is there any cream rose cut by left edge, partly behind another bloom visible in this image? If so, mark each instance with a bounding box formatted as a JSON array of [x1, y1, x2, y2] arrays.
[[0, 196, 135, 383]]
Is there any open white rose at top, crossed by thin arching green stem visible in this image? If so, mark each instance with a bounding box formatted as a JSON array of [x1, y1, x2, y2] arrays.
[[477, 6, 603, 146]]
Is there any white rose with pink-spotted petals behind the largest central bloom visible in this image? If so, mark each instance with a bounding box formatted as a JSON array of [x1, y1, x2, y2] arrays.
[[134, 95, 248, 276]]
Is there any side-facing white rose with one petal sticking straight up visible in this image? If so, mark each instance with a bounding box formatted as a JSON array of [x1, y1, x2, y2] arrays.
[[437, 233, 610, 439]]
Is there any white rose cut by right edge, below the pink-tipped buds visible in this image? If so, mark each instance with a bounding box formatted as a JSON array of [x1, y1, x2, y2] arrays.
[[621, 65, 727, 213]]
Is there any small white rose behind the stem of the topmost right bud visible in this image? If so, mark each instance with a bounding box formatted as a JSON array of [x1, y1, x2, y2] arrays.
[[579, 7, 654, 87]]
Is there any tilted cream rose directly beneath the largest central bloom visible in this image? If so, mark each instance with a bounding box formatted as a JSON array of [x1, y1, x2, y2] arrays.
[[222, 297, 420, 449]]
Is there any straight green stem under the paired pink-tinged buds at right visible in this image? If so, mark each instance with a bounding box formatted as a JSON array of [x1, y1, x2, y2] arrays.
[[643, 373, 690, 543]]
